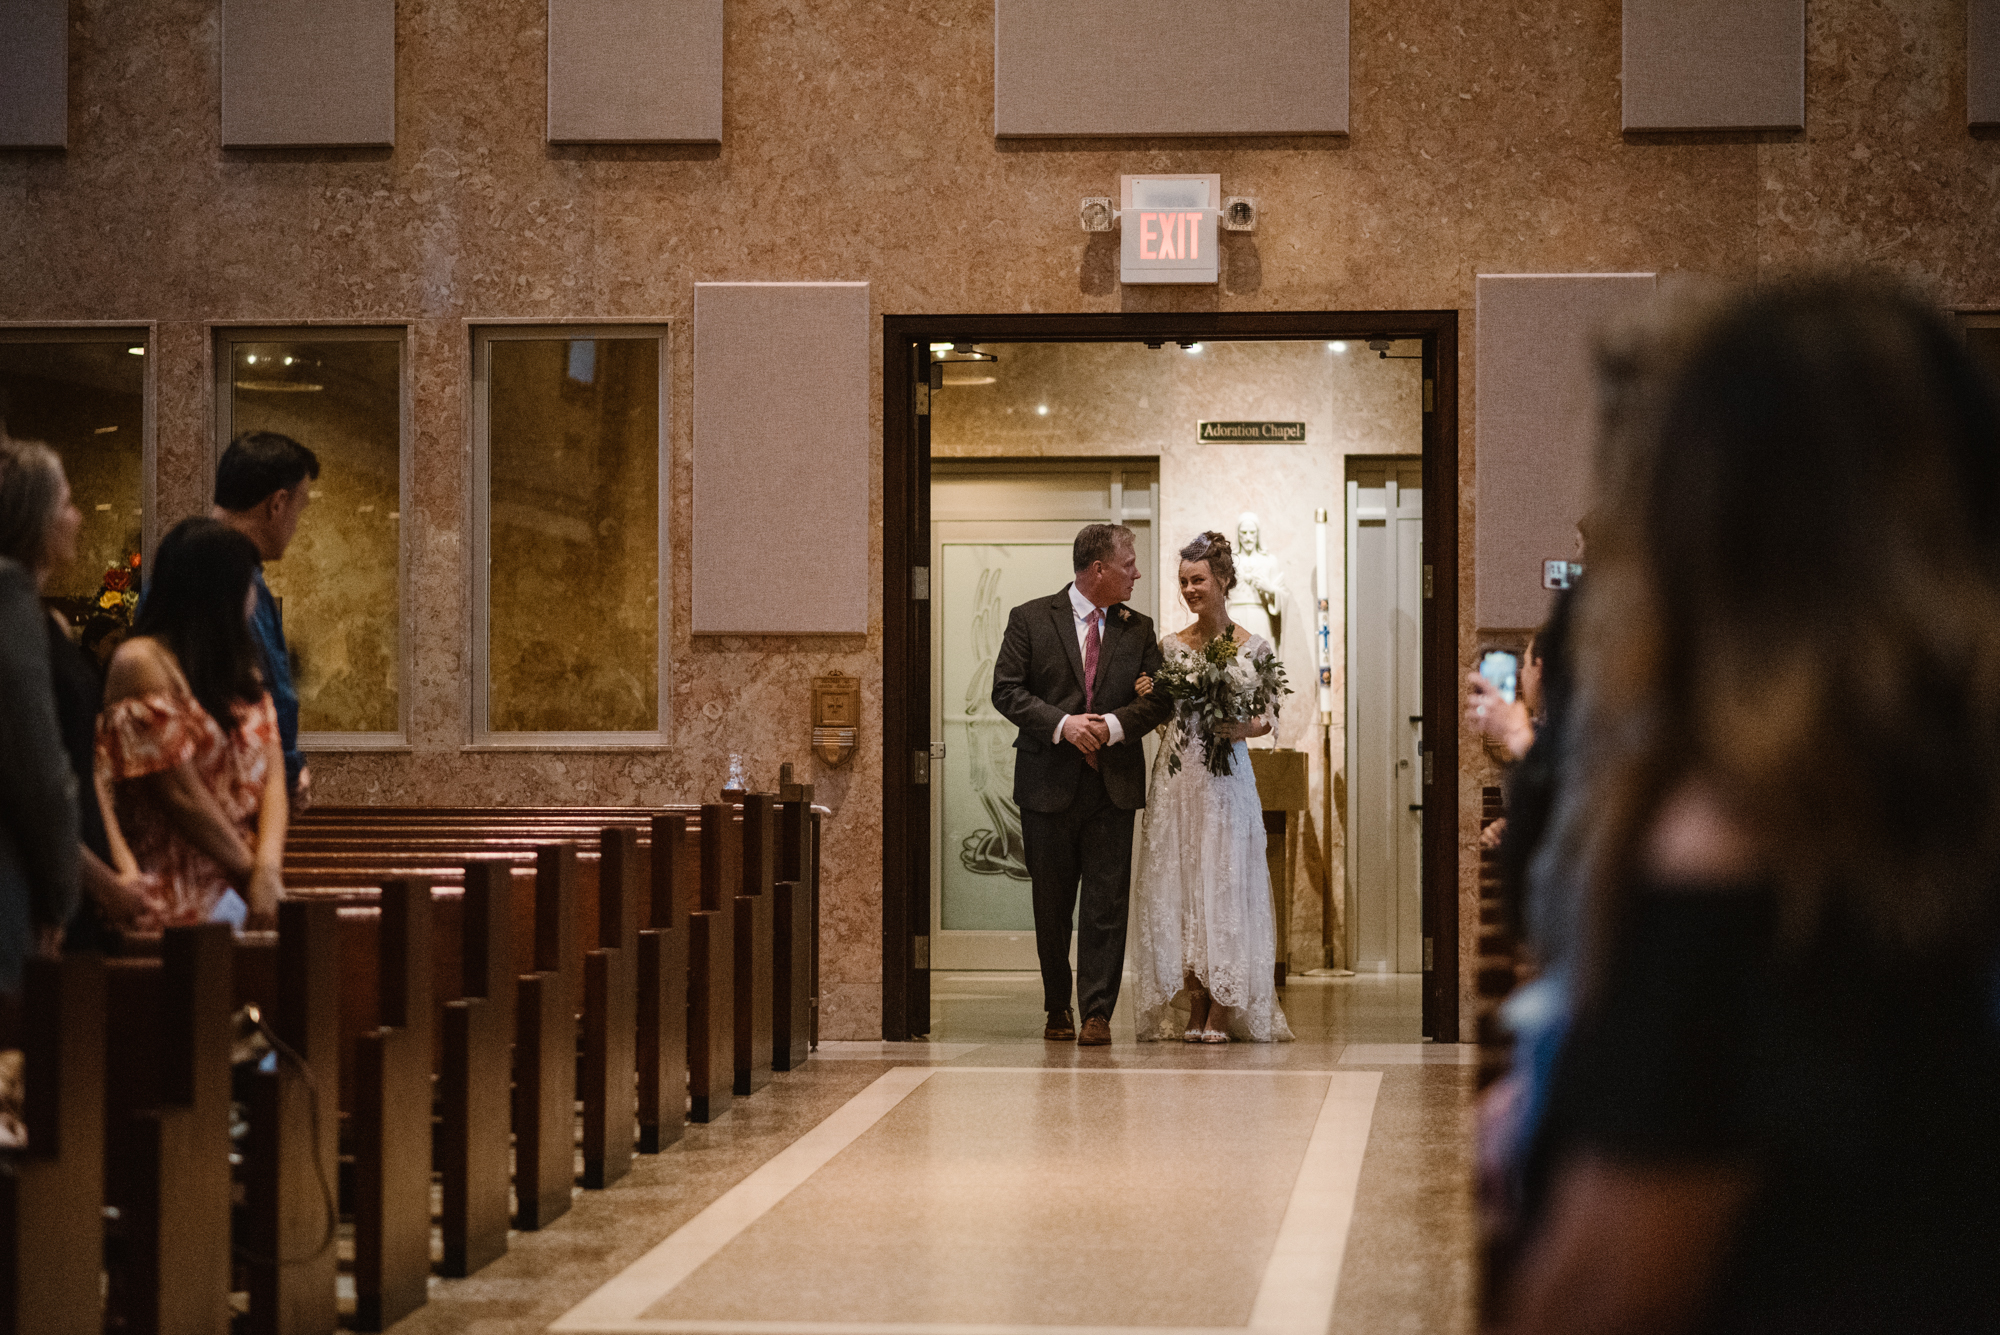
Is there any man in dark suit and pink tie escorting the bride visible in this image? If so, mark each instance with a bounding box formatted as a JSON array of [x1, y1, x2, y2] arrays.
[[994, 524, 1172, 1045]]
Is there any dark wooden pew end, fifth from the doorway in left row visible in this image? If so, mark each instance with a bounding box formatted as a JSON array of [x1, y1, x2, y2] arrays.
[[582, 825, 648, 1187]]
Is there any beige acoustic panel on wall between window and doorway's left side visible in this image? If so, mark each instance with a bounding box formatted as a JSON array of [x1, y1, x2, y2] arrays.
[[694, 282, 872, 636]]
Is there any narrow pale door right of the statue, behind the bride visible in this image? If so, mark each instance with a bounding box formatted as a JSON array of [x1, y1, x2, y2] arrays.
[[1346, 458, 1424, 973]]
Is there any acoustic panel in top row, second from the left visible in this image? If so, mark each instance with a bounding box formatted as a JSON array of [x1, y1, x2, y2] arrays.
[[222, 0, 396, 148]]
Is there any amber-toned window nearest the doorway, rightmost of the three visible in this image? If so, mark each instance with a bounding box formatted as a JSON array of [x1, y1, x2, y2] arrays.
[[472, 324, 668, 747]]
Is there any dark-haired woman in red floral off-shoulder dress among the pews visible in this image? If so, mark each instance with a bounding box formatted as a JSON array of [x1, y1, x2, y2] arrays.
[[96, 520, 288, 927]]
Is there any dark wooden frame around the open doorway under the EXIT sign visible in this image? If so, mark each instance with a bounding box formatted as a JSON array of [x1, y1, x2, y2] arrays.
[[882, 310, 1460, 1043]]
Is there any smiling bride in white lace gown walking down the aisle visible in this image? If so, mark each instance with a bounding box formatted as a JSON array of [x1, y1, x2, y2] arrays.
[[1132, 534, 1292, 1043]]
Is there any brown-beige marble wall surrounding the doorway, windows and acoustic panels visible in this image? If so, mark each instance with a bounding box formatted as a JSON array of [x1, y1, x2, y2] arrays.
[[0, 0, 2000, 1037]]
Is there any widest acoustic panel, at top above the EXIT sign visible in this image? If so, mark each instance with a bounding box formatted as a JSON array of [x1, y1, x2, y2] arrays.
[[994, 0, 1348, 138]]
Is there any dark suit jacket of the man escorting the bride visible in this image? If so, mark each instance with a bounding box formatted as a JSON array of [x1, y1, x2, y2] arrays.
[[994, 586, 1174, 811]]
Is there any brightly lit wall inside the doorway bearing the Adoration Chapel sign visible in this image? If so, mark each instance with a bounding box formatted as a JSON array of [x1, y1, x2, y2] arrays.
[[930, 340, 1422, 969]]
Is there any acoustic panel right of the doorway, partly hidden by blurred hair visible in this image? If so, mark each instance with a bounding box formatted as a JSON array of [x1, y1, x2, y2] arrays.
[[1472, 274, 1654, 630]]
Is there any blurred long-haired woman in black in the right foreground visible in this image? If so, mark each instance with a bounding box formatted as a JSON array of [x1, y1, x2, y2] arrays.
[[1498, 280, 2000, 1333]]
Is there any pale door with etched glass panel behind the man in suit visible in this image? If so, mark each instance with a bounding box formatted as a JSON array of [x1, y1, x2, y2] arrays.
[[930, 460, 1160, 969]]
